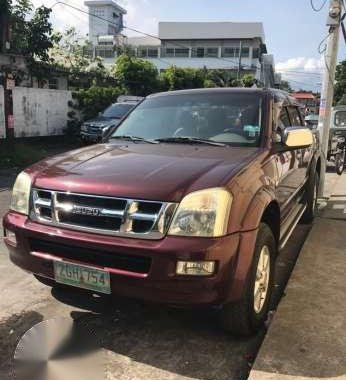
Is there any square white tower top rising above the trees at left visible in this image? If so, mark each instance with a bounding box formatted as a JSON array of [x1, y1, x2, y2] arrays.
[[84, 0, 127, 45]]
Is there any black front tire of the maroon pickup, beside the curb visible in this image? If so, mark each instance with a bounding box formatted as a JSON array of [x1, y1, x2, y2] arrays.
[[219, 223, 277, 336]]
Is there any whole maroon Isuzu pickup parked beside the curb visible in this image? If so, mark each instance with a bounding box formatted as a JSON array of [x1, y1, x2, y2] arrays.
[[3, 89, 321, 334]]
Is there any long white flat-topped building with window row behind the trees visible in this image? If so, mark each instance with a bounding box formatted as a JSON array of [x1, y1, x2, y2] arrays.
[[88, 17, 275, 86]]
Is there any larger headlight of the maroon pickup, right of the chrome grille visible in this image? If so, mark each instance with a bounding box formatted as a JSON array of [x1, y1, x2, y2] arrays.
[[168, 188, 232, 237]]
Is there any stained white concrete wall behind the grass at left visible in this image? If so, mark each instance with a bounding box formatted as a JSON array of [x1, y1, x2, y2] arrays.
[[13, 87, 72, 137]]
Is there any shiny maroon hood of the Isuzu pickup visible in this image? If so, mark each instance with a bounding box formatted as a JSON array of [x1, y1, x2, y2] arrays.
[[27, 142, 261, 202]]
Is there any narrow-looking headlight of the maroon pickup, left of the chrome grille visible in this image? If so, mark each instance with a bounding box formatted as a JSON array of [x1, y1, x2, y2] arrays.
[[11, 172, 31, 215]]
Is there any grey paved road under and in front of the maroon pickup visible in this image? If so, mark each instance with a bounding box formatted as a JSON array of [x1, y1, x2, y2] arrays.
[[0, 173, 310, 380]]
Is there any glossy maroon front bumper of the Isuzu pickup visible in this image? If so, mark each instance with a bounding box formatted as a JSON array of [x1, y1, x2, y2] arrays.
[[3, 211, 253, 306]]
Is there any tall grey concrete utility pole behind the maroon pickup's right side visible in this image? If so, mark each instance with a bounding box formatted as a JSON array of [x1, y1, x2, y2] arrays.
[[318, 0, 342, 197]]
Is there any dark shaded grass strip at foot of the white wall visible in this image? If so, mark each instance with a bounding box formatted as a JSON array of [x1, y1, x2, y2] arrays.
[[0, 137, 78, 169]]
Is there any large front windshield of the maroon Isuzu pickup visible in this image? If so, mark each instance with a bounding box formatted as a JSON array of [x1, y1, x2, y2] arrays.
[[112, 92, 262, 146]]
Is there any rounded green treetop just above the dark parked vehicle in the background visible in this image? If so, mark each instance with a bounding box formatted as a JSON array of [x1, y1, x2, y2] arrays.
[[112, 54, 159, 96]]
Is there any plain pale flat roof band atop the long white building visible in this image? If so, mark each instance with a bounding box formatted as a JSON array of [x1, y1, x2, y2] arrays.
[[159, 22, 265, 41]]
